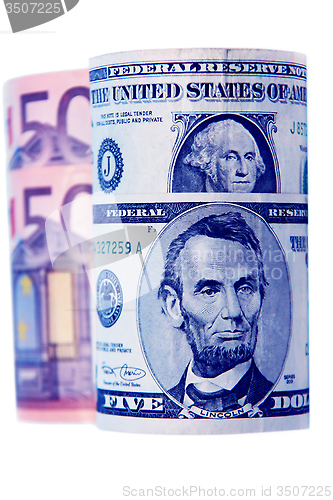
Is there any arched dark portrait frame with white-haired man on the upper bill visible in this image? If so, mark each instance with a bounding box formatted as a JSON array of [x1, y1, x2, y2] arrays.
[[169, 113, 280, 193]]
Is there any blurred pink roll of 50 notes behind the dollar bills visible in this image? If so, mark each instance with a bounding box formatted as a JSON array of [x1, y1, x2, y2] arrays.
[[4, 70, 96, 421]]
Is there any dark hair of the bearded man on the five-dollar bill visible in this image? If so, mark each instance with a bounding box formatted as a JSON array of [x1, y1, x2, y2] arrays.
[[158, 212, 268, 301]]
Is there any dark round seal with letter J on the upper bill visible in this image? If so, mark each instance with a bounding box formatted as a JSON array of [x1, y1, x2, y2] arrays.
[[97, 139, 124, 193]]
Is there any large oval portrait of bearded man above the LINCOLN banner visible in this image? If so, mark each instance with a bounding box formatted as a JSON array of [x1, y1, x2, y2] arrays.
[[137, 202, 292, 410]]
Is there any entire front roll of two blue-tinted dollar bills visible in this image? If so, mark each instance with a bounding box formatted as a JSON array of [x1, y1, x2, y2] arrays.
[[90, 49, 309, 434]]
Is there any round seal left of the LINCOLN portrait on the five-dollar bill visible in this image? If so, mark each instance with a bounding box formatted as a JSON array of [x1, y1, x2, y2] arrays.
[[97, 269, 123, 328]]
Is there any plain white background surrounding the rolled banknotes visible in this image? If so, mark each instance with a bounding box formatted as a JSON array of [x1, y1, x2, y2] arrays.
[[0, 0, 333, 500]]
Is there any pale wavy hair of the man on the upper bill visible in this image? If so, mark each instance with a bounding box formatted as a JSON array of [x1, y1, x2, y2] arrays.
[[184, 119, 266, 183]]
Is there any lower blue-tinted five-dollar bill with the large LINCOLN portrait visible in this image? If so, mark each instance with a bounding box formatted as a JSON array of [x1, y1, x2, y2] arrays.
[[93, 192, 309, 434]]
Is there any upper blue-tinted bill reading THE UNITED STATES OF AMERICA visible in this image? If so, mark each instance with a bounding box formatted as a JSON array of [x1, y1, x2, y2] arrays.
[[90, 49, 307, 195]]
